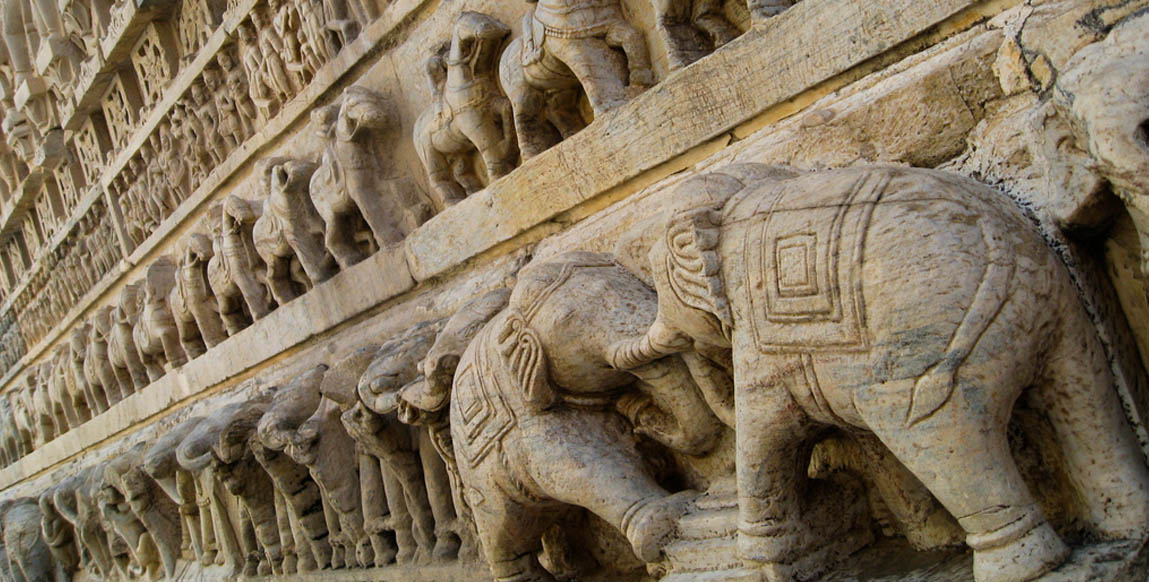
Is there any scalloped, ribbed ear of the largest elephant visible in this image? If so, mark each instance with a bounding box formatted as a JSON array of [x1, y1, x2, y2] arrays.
[[655, 207, 734, 329]]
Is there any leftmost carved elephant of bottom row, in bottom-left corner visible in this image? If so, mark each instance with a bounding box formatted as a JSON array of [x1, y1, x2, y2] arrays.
[[0, 497, 71, 582]]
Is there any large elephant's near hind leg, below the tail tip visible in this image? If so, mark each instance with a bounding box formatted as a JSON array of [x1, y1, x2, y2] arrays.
[[859, 378, 1069, 582]]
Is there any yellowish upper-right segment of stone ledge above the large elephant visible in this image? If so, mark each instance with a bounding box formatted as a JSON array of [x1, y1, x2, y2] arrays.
[[407, 0, 997, 281]]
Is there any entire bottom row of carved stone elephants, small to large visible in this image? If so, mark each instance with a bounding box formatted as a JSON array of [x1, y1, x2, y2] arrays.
[[3, 164, 1149, 582]]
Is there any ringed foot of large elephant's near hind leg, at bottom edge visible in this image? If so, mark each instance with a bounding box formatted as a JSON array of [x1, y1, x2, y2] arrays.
[[969, 521, 1070, 582]]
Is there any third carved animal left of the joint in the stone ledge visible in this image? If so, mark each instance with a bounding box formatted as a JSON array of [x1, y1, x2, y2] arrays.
[[208, 195, 275, 335]]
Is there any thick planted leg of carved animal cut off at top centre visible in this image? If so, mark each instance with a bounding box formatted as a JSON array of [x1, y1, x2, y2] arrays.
[[546, 38, 627, 117]]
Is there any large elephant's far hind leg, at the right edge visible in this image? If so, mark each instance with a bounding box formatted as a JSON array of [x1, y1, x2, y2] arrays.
[[1032, 316, 1149, 540]]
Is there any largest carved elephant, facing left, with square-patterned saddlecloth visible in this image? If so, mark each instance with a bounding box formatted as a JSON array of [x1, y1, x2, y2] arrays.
[[612, 165, 1149, 582]]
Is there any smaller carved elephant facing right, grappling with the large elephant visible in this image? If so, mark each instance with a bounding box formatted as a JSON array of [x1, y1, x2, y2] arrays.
[[408, 253, 722, 581]]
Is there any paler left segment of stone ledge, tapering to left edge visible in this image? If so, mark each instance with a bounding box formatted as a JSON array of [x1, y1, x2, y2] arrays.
[[0, 247, 415, 490]]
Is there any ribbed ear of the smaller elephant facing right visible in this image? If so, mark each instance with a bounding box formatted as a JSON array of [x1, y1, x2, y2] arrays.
[[496, 312, 558, 412]]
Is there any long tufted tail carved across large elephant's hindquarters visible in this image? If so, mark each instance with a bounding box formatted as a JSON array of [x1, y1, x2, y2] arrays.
[[905, 207, 1016, 426]]
